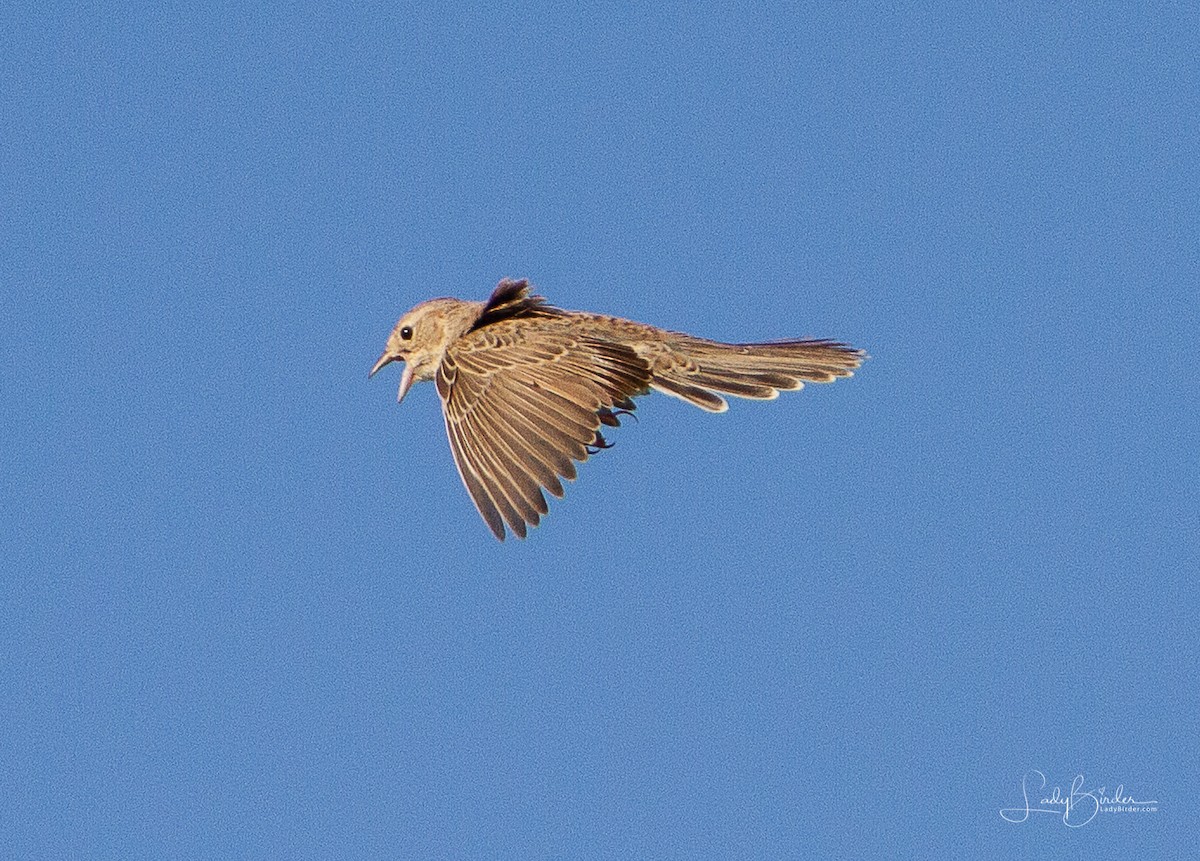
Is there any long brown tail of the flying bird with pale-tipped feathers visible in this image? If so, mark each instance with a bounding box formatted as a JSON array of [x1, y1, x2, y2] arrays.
[[650, 337, 866, 413]]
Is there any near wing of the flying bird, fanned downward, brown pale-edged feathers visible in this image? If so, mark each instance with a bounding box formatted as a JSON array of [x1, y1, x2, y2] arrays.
[[437, 320, 650, 541]]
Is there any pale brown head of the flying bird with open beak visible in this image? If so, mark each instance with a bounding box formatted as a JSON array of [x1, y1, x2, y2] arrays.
[[367, 299, 482, 403]]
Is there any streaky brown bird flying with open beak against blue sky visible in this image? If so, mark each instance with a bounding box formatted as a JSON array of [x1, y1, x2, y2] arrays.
[[368, 278, 866, 541]]
